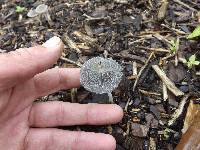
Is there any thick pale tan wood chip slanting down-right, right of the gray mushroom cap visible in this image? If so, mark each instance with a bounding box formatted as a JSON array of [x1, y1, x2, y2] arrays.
[[152, 65, 184, 96]]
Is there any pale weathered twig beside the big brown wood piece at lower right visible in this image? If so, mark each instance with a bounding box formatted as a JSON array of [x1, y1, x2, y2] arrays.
[[168, 94, 190, 126]]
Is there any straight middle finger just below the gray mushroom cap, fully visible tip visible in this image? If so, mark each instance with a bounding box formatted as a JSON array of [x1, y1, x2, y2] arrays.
[[29, 102, 123, 127]]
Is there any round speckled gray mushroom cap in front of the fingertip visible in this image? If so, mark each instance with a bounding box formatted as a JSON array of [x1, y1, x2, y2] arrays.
[[80, 57, 123, 94]]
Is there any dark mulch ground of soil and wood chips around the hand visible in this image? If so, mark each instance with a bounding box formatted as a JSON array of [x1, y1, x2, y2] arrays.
[[0, 0, 200, 150]]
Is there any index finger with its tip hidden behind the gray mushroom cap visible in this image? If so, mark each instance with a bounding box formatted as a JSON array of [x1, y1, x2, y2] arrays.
[[32, 68, 80, 97]]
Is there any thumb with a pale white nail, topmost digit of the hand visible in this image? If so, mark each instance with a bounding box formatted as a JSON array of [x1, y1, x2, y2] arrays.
[[0, 36, 64, 90]]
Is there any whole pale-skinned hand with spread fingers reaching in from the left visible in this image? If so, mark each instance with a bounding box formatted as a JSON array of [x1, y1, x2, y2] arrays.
[[0, 37, 123, 150]]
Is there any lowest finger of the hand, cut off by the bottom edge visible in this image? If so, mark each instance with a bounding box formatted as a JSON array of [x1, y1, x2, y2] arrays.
[[24, 129, 116, 150]]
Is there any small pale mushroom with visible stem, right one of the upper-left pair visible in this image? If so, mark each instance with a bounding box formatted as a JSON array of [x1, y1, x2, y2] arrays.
[[35, 4, 53, 26]]
